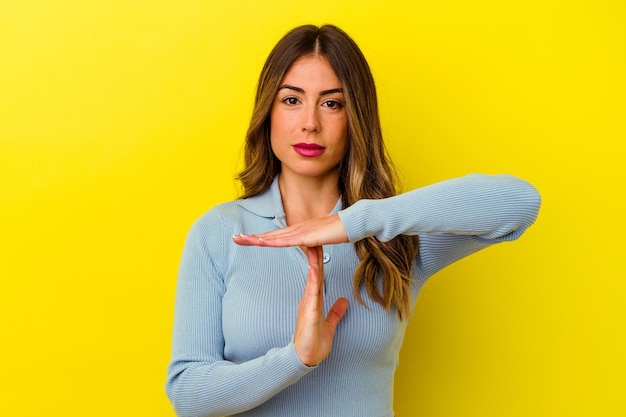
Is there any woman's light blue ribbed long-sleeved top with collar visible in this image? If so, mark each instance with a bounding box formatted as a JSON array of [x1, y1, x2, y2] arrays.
[[166, 174, 540, 417]]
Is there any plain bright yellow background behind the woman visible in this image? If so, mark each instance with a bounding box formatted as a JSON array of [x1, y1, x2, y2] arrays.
[[0, 0, 626, 417]]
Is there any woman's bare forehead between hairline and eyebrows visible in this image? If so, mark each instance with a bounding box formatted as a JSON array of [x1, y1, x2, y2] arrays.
[[281, 55, 342, 89]]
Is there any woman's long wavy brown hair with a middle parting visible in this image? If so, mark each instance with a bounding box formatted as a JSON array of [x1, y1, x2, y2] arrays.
[[238, 25, 418, 319]]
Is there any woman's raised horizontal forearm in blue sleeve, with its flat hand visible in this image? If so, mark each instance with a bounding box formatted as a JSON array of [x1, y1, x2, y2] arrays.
[[233, 174, 541, 250]]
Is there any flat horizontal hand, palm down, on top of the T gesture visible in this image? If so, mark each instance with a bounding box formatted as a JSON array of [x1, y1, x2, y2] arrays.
[[233, 214, 349, 248]]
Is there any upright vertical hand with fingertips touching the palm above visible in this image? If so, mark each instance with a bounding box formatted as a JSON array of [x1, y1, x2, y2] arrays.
[[294, 246, 348, 366]]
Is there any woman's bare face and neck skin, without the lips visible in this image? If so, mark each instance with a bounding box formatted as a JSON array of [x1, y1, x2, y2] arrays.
[[270, 55, 348, 225]]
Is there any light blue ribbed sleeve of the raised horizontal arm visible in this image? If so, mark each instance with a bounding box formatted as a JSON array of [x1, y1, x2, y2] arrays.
[[339, 174, 541, 276]]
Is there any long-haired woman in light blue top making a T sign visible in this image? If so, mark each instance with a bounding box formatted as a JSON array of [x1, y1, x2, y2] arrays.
[[167, 26, 540, 417]]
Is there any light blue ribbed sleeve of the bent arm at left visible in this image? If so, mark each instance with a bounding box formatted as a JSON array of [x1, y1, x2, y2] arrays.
[[166, 211, 311, 416]]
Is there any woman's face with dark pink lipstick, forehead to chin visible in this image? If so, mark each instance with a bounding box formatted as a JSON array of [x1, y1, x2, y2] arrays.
[[270, 56, 348, 181]]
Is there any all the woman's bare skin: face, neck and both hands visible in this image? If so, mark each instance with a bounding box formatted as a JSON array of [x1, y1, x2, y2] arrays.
[[233, 55, 348, 366]]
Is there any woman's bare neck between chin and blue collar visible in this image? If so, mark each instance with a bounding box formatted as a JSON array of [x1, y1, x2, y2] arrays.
[[278, 173, 340, 225]]
